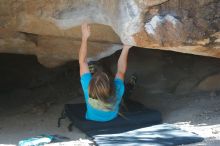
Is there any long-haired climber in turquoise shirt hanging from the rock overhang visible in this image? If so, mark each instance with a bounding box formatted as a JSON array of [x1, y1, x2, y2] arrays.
[[79, 23, 131, 122]]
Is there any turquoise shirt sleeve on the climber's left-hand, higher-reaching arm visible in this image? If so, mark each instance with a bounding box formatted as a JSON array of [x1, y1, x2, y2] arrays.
[[80, 73, 92, 102]]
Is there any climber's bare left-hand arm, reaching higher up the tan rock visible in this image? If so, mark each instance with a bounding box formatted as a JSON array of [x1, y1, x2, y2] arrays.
[[79, 23, 90, 76]]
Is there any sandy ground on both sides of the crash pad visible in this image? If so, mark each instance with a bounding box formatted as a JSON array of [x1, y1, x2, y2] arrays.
[[0, 83, 220, 146]]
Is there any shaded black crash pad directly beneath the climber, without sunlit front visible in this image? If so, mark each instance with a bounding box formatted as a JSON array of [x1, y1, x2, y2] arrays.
[[65, 102, 162, 136]]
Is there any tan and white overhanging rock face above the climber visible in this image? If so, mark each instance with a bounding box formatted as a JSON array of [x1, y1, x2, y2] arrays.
[[0, 0, 220, 67]]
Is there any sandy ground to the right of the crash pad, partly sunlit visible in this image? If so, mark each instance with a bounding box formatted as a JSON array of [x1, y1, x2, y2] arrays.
[[134, 92, 220, 146]]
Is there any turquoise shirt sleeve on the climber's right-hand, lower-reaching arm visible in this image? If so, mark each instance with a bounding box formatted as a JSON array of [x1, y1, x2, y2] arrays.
[[114, 78, 125, 104]]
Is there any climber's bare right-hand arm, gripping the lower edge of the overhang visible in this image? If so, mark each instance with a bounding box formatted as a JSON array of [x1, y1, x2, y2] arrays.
[[116, 45, 131, 80]]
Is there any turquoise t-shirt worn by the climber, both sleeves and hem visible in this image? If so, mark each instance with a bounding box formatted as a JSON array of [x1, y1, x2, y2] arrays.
[[81, 73, 124, 122]]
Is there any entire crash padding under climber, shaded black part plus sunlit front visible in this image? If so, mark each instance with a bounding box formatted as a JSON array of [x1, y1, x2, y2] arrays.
[[61, 101, 203, 146]]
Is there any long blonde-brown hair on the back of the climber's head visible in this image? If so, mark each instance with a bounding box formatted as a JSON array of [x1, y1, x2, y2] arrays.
[[89, 71, 116, 108]]
